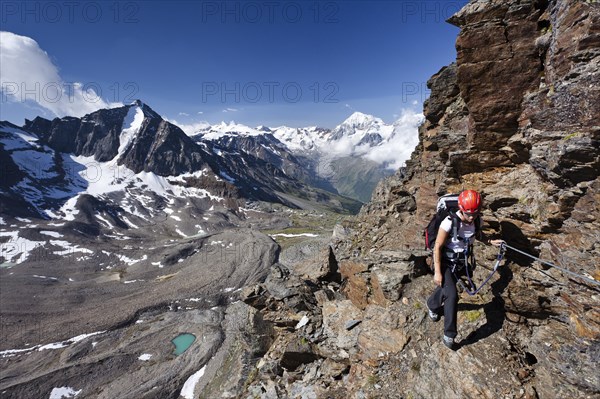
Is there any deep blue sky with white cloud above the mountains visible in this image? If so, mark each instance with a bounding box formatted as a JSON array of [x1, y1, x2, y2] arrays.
[[0, 0, 467, 127]]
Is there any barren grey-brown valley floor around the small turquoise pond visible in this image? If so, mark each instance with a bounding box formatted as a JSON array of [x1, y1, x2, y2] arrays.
[[0, 204, 343, 398]]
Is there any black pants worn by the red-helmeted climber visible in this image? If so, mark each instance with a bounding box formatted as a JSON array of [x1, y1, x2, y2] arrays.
[[427, 262, 458, 338]]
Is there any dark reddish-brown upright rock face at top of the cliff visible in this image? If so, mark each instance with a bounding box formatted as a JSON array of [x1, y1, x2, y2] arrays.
[[450, 1, 545, 147]]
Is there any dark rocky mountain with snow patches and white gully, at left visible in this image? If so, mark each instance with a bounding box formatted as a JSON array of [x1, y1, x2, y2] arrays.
[[0, 101, 364, 228]]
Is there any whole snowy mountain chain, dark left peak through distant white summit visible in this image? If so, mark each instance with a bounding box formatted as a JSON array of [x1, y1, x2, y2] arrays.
[[0, 100, 416, 235]]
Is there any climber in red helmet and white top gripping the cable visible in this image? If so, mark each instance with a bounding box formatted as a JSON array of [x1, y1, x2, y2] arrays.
[[427, 190, 504, 349]]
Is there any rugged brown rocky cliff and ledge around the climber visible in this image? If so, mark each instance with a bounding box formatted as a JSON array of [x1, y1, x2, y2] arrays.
[[229, 0, 600, 398]]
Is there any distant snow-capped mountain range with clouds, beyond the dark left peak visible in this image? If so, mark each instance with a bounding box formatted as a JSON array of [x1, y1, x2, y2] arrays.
[[192, 112, 422, 202]]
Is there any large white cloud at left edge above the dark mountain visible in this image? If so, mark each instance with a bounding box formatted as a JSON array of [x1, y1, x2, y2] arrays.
[[0, 31, 123, 117]]
